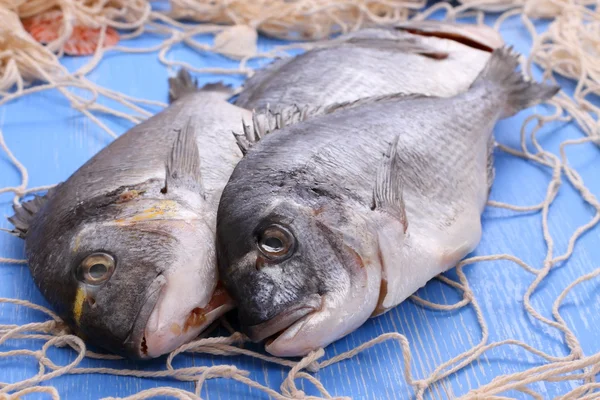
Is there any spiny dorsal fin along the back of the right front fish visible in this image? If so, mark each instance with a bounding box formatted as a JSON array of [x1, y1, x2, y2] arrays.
[[232, 93, 432, 155]]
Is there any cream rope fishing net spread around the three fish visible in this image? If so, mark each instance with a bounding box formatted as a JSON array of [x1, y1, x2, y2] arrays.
[[0, 0, 600, 400]]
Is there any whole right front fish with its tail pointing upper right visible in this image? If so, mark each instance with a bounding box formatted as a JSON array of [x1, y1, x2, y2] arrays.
[[217, 47, 559, 357]]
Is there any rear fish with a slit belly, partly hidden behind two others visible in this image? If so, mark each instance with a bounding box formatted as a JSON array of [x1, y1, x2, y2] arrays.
[[234, 21, 504, 110]]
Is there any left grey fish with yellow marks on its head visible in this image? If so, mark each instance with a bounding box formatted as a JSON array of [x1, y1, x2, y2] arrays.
[[10, 70, 252, 359]]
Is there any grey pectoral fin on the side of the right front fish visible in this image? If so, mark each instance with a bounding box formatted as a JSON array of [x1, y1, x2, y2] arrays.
[[372, 136, 408, 232]]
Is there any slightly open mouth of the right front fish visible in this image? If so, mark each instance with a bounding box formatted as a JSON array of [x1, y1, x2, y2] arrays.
[[245, 294, 322, 342]]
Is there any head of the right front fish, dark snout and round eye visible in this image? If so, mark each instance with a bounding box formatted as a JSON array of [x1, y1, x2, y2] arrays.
[[217, 191, 381, 356]]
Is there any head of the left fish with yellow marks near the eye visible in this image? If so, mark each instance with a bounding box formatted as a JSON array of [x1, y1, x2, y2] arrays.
[[26, 188, 231, 359]]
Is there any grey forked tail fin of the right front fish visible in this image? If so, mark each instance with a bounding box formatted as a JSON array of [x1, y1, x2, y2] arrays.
[[471, 47, 560, 118]]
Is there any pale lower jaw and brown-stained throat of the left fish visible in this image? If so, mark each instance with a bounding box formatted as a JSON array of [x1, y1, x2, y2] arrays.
[[141, 284, 234, 358]]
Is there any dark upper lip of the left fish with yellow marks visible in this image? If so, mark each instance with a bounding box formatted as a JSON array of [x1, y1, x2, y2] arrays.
[[123, 274, 167, 360]]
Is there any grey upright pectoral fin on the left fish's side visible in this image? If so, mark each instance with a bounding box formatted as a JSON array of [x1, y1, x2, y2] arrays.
[[163, 118, 203, 193]]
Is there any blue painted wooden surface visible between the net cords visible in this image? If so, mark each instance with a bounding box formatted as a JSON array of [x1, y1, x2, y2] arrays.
[[0, 3, 600, 399]]
